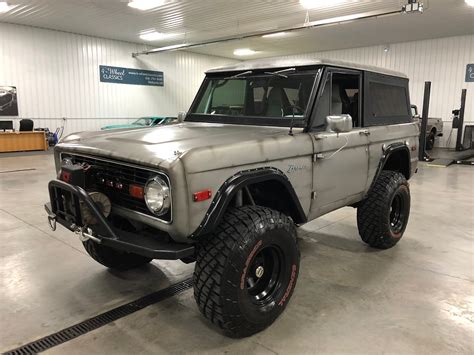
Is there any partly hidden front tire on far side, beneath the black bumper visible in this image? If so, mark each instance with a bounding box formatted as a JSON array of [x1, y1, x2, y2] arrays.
[[82, 239, 152, 271]]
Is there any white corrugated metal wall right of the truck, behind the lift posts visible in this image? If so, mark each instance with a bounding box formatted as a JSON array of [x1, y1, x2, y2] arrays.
[[287, 35, 474, 146]]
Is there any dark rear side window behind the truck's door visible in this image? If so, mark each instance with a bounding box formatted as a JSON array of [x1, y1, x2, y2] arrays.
[[364, 73, 411, 126]]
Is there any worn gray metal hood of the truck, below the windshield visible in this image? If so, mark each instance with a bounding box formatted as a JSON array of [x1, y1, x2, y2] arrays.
[[57, 122, 288, 169]]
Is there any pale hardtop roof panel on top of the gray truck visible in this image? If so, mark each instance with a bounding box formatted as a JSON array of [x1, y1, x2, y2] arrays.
[[206, 58, 407, 78]]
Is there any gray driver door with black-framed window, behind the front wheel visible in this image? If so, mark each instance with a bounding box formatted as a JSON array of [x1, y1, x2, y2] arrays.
[[310, 69, 369, 218]]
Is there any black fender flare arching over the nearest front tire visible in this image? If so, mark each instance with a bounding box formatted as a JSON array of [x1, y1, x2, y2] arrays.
[[190, 167, 307, 239]]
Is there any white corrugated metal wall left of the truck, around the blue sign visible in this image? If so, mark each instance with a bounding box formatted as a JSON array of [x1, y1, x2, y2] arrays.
[[0, 23, 235, 136]]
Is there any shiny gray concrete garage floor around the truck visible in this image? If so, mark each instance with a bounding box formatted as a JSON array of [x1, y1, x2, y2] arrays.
[[0, 155, 474, 354]]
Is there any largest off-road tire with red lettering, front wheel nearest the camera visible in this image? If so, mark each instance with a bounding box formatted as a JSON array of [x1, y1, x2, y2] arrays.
[[193, 206, 300, 338]]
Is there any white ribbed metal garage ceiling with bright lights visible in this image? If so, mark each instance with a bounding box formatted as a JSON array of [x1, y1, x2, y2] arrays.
[[0, 0, 474, 59]]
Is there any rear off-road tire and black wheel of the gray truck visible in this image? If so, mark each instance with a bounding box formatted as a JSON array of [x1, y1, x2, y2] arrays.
[[357, 170, 410, 249]]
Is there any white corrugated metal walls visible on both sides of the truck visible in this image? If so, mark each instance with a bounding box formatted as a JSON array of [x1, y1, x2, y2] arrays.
[[0, 23, 474, 145]]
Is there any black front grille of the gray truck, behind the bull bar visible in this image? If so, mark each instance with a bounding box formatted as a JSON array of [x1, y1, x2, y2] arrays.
[[66, 155, 171, 222]]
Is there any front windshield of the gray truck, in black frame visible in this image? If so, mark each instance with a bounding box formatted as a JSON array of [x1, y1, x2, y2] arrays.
[[189, 69, 317, 125]]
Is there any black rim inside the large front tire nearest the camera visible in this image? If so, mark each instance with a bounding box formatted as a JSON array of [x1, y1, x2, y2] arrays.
[[246, 246, 284, 308]]
